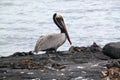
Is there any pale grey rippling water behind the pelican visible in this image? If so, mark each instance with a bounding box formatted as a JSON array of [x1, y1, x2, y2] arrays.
[[0, 0, 120, 56]]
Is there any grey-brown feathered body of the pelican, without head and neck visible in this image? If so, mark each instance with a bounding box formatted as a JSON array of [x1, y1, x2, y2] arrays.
[[34, 33, 66, 53]]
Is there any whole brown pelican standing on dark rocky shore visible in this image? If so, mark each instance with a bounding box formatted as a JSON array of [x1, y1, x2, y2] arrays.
[[34, 13, 72, 53]]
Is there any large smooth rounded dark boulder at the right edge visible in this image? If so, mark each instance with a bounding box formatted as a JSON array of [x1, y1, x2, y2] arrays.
[[103, 42, 120, 59]]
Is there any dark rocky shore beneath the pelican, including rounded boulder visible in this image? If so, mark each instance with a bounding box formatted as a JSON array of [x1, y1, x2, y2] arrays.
[[0, 42, 120, 80]]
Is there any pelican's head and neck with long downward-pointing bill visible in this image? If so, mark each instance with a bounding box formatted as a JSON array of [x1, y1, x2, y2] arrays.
[[53, 13, 72, 45]]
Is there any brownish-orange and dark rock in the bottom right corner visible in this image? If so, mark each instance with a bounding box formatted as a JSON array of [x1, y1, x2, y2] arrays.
[[101, 59, 120, 80]]
